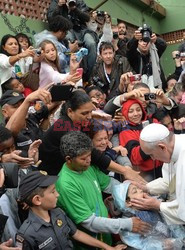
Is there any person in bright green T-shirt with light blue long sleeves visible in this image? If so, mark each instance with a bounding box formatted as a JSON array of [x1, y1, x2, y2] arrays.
[[56, 131, 149, 248]]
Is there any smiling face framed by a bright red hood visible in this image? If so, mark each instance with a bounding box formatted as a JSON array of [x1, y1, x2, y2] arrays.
[[128, 103, 143, 124]]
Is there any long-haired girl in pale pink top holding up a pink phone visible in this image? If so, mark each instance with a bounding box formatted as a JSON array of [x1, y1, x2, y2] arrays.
[[39, 40, 81, 87]]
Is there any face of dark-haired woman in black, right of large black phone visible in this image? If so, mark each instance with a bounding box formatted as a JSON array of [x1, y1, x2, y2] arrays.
[[67, 102, 94, 126]]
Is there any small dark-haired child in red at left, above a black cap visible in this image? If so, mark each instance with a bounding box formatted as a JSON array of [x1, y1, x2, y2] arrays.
[[2, 78, 33, 97]]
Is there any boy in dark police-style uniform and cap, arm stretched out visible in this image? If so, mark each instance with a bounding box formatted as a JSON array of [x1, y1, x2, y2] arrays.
[[16, 171, 123, 250]]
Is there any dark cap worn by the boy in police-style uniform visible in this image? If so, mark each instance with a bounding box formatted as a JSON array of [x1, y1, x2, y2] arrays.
[[19, 171, 58, 201]]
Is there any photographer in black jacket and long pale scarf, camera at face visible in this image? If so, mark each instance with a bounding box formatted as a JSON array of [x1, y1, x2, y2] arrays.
[[127, 24, 167, 89]]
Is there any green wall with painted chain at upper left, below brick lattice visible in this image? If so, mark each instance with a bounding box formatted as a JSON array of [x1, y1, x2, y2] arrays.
[[0, 13, 47, 45]]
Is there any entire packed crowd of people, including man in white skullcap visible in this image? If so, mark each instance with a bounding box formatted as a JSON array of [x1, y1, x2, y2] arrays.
[[0, 0, 185, 250]]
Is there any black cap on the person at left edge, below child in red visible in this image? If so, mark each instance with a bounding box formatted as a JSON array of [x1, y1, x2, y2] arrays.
[[0, 90, 25, 107]]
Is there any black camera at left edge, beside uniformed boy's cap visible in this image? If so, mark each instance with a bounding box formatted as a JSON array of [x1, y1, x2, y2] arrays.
[[0, 162, 19, 188]]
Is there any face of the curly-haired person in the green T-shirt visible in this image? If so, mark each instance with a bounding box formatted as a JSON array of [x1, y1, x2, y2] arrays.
[[67, 151, 91, 172]]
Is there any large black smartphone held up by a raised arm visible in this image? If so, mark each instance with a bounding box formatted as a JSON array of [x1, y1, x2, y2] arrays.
[[50, 83, 74, 102]]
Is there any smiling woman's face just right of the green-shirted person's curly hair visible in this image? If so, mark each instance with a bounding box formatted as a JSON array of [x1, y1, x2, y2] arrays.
[[92, 130, 109, 152]]
